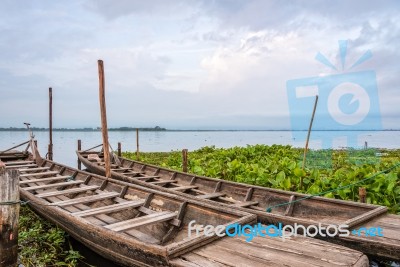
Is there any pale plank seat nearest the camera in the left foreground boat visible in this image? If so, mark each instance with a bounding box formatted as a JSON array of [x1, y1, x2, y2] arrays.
[[105, 211, 176, 232]]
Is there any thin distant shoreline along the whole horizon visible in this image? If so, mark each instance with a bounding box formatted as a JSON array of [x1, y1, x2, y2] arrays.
[[0, 126, 400, 132]]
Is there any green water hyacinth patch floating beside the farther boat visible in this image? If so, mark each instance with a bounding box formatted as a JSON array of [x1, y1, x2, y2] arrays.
[[123, 145, 400, 214]]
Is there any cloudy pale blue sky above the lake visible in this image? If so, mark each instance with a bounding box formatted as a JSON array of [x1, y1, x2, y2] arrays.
[[0, 0, 400, 130]]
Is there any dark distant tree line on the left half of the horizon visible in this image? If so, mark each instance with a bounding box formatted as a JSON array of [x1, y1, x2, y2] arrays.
[[0, 126, 167, 132]]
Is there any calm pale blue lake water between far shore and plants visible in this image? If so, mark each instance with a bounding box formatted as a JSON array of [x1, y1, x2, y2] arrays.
[[0, 131, 400, 167]]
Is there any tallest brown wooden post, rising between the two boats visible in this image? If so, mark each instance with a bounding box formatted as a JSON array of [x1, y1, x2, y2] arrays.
[[97, 60, 111, 178]]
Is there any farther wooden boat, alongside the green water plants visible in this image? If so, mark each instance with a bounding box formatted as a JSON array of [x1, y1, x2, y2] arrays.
[[77, 150, 400, 260]]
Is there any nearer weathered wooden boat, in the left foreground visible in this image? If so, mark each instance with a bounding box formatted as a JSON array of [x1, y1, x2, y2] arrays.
[[0, 141, 368, 267]]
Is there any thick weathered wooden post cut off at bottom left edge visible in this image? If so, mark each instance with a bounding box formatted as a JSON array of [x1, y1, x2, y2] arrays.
[[0, 161, 19, 267]]
